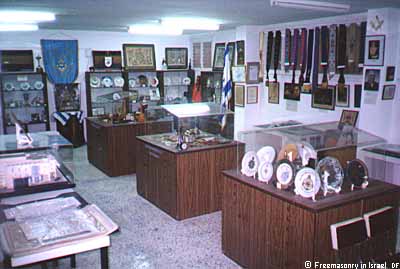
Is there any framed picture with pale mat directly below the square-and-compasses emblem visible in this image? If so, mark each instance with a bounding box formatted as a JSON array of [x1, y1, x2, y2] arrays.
[[364, 35, 385, 66]]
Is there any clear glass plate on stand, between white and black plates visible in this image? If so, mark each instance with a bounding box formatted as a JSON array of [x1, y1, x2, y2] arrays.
[[316, 157, 344, 195]]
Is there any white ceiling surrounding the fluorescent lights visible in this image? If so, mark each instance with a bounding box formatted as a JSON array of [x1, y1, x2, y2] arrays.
[[0, 0, 400, 31]]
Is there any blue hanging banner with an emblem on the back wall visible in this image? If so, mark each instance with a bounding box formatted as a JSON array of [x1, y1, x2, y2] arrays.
[[40, 39, 78, 84]]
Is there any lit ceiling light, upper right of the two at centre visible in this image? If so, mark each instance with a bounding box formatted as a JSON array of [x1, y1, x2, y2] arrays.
[[161, 18, 220, 31]]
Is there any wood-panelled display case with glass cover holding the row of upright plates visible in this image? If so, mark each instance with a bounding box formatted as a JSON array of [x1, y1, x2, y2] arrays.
[[222, 122, 400, 268]]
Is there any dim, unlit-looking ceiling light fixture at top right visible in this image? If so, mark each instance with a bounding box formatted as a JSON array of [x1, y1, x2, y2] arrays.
[[271, 0, 350, 12]]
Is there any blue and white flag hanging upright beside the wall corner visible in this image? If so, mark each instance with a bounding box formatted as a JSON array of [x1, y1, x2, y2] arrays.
[[221, 46, 232, 130]]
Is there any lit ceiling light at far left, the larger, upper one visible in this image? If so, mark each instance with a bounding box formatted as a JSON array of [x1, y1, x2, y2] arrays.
[[0, 10, 56, 23]]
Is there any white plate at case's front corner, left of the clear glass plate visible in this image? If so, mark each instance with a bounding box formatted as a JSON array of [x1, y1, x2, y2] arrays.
[[294, 167, 321, 200]]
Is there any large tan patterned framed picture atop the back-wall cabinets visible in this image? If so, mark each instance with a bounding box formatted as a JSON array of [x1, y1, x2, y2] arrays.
[[122, 44, 156, 70]]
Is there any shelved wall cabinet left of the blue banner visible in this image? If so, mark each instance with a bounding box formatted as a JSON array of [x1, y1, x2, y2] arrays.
[[0, 72, 50, 134]]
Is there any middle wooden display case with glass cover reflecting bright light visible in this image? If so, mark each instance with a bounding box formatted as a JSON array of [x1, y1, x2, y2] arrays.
[[136, 103, 244, 220]]
